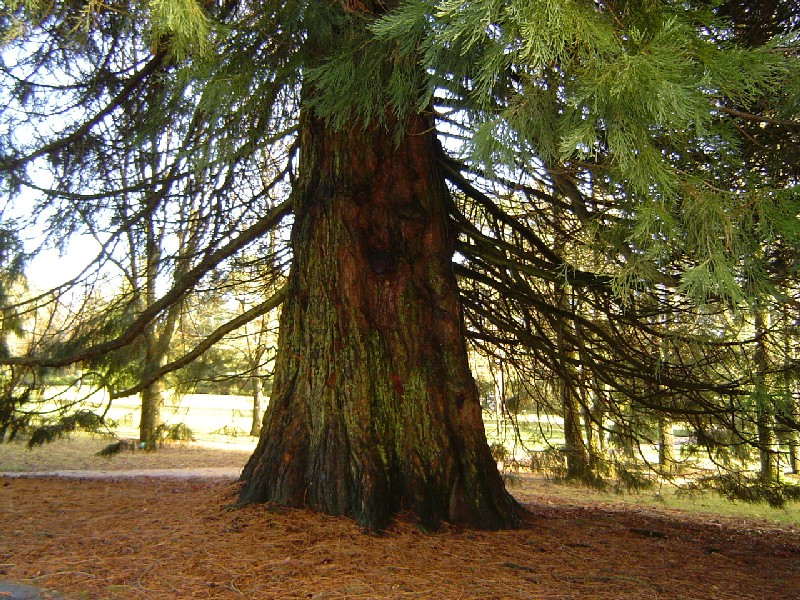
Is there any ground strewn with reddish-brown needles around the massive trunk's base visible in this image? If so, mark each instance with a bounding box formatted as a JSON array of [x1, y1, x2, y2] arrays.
[[0, 439, 800, 600]]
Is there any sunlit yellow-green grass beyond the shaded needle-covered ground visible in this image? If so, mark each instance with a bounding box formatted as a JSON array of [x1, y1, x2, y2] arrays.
[[12, 395, 800, 526]]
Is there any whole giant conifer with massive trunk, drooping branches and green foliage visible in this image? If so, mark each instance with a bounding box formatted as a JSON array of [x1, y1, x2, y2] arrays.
[[0, 0, 800, 528]]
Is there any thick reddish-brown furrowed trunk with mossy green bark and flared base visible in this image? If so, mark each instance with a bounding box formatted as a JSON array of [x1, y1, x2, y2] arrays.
[[240, 113, 517, 530]]
